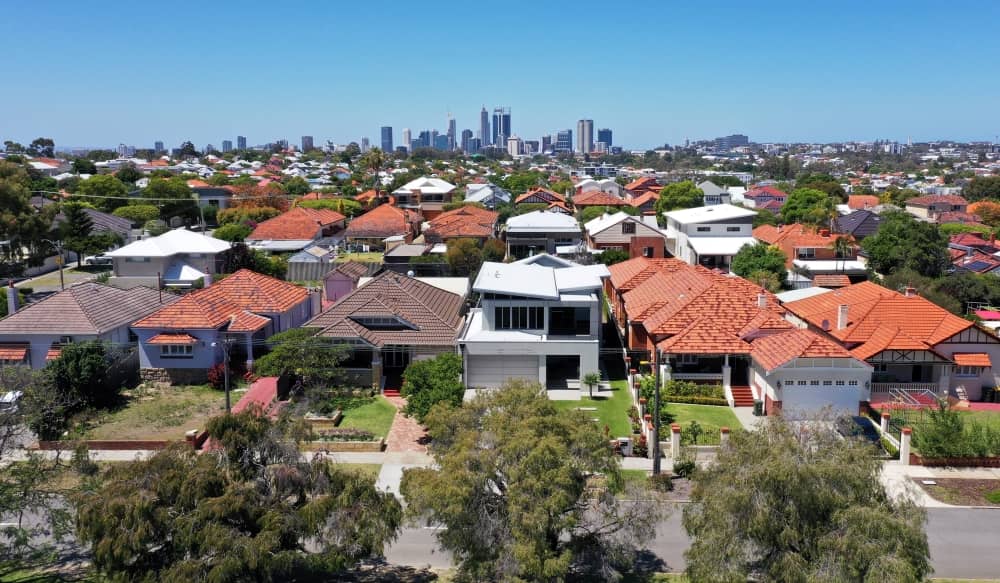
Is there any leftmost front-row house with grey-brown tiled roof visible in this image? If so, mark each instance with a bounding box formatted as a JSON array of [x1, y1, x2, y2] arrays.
[[0, 282, 179, 368]]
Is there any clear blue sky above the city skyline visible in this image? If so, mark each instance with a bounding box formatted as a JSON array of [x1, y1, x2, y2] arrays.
[[0, 0, 1000, 148]]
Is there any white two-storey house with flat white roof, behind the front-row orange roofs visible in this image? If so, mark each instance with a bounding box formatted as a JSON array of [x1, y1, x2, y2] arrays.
[[663, 204, 757, 271]]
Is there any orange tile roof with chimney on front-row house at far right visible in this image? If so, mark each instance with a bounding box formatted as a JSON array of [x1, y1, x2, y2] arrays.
[[785, 281, 973, 358]]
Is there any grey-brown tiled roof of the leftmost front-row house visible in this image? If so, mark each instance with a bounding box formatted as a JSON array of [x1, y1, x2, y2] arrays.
[[0, 282, 179, 336]]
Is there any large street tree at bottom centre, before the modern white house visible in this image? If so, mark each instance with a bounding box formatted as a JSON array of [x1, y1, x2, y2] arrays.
[[401, 380, 662, 581]]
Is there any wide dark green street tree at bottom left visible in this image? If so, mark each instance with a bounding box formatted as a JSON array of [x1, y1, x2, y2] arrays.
[[74, 409, 402, 581]]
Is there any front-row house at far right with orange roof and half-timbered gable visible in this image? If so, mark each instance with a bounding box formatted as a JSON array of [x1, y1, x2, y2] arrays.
[[784, 282, 1000, 403]]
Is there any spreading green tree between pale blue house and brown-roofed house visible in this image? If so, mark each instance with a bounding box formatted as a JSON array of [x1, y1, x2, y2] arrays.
[[254, 328, 347, 387]]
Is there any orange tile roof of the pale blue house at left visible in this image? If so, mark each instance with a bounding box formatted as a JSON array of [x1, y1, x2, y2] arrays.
[[132, 269, 309, 331]]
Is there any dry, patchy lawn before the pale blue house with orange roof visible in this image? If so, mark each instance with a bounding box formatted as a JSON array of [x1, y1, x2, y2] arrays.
[[78, 385, 227, 441]]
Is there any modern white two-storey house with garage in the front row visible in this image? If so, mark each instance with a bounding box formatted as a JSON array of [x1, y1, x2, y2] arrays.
[[458, 255, 609, 389]]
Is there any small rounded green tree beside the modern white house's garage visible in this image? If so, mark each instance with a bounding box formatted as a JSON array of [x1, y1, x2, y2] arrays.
[[400, 352, 465, 423]]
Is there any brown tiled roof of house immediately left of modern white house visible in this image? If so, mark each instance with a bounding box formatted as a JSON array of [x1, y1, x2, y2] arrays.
[[303, 271, 464, 347]]
